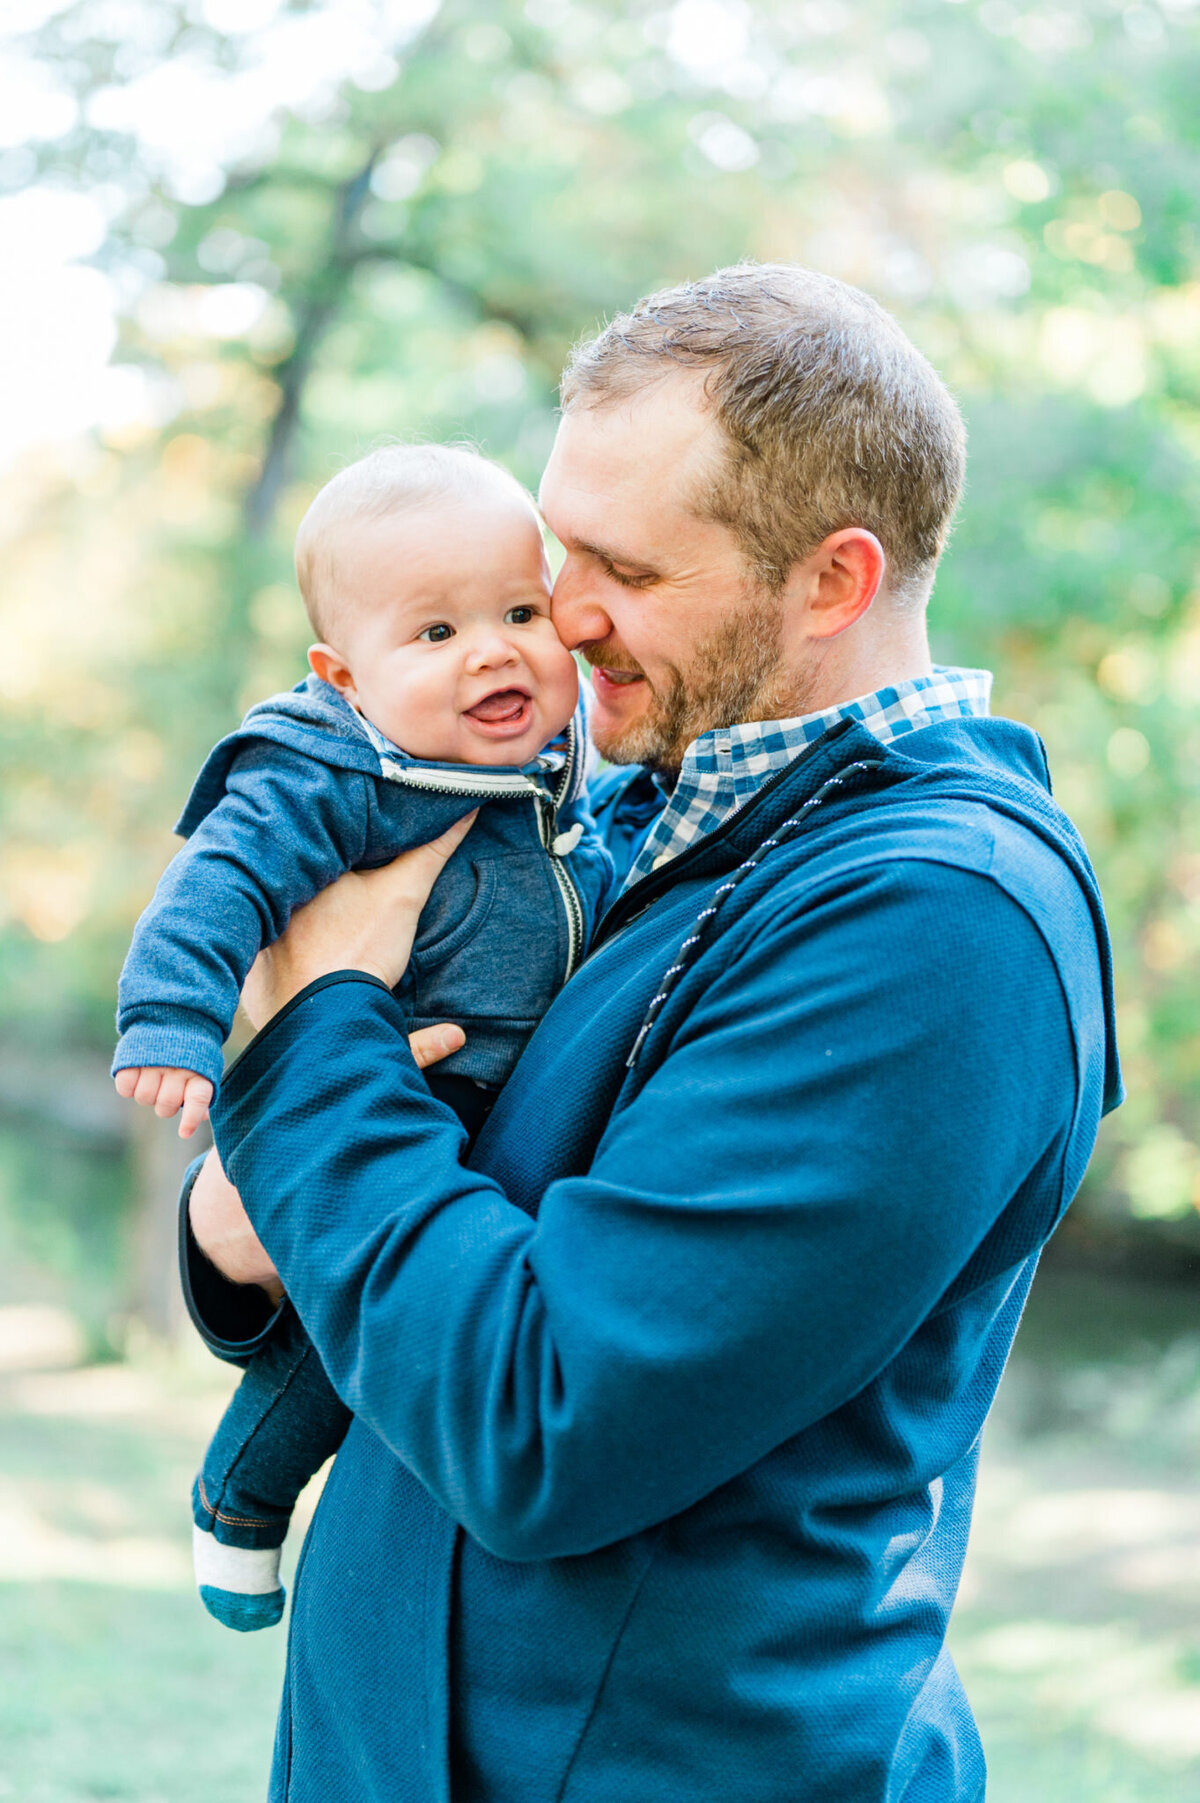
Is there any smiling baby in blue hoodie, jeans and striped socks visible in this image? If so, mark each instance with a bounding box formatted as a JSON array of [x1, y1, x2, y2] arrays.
[[114, 445, 611, 1628]]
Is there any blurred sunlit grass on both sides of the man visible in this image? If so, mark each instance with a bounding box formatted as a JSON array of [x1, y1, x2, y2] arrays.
[[0, 1269, 1200, 1803]]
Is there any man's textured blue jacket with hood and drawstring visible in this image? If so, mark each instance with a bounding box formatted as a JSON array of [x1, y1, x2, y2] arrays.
[[193, 719, 1121, 1803]]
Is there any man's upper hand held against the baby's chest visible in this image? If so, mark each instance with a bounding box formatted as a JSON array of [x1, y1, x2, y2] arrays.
[[241, 810, 477, 1031]]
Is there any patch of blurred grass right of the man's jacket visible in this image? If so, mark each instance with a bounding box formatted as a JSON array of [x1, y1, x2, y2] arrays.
[[951, 1268, 1200, 1803]]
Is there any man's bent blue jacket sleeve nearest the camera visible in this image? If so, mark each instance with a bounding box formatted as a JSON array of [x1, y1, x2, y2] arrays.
[[214, 862, 1076, 1560]]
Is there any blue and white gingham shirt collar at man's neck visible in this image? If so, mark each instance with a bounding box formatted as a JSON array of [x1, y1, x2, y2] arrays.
[[625, 667, 991, 887]]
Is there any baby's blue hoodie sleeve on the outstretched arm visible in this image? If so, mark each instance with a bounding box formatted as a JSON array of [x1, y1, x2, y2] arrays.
[[112, 739, 368, 1085]]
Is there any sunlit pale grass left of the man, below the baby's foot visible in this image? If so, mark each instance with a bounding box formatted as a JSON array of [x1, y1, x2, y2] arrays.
[[0, 1358, 285, 1803]]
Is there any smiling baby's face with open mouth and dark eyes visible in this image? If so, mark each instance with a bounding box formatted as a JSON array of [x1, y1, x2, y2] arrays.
[[314, 490, 578, 764]]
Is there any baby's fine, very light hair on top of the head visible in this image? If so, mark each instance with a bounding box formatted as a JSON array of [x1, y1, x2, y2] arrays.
[[295, 444, 537, 638]]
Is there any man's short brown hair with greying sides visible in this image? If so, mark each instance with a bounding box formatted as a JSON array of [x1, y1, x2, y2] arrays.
[[562, 263, 966, 602]]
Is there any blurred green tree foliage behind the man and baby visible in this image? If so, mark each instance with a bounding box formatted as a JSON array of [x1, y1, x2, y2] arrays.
[[0, 0, 1200, 1221]]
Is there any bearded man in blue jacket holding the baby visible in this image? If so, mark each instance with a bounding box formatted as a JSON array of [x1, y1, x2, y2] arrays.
[[189, 267, 1119, 1803]]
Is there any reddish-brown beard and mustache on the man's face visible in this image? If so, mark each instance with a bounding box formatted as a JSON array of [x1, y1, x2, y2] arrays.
[[580, 595, 795, 772]]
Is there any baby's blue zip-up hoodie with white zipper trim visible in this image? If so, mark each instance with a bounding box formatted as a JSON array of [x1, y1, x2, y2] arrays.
[[114, 676, 611, 1085]]
